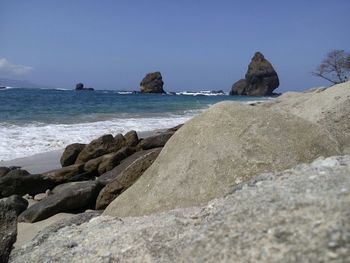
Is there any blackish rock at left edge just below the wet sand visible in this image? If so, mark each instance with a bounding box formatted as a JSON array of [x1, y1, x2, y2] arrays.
[[0, 169, 55, 197]]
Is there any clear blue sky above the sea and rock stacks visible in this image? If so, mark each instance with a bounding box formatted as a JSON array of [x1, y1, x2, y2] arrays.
[[0, 0, 350, 92]]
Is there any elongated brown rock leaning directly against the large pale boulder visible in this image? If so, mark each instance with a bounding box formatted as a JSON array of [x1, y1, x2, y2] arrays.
[[96, 148, 161, 209]]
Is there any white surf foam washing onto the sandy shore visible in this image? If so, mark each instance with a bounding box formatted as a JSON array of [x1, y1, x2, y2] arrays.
[[0, 115, 194, 160]]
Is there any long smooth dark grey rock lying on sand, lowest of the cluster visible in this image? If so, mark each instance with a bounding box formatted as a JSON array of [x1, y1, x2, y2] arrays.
[[18, 181, 101, 223]]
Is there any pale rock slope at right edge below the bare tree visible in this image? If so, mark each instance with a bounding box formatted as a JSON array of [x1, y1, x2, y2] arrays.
[[260, 81, 350, 154]]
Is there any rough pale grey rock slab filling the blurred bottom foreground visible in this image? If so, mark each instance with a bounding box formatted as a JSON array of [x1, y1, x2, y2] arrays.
[[10, 156, 350, 263]]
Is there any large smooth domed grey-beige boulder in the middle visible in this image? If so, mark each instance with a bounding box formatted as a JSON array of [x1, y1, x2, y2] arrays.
[[104, 102, 339, 216]]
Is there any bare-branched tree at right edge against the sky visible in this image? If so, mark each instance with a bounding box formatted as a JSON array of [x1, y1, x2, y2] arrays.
[[312, 50, 350, 84]]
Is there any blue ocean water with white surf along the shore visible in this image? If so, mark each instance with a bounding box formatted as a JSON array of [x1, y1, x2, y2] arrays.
[[0, 88, 266, 160]]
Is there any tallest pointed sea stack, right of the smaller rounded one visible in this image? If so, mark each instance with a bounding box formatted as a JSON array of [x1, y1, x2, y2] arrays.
[[230, 52, 279, 96]]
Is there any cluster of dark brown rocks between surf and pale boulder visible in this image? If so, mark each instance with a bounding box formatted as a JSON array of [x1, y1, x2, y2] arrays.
[[0, 126, 181, 237]]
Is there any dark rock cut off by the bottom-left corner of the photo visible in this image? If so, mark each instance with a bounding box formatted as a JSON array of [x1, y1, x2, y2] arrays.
[[0, 196, 28, 263]]
